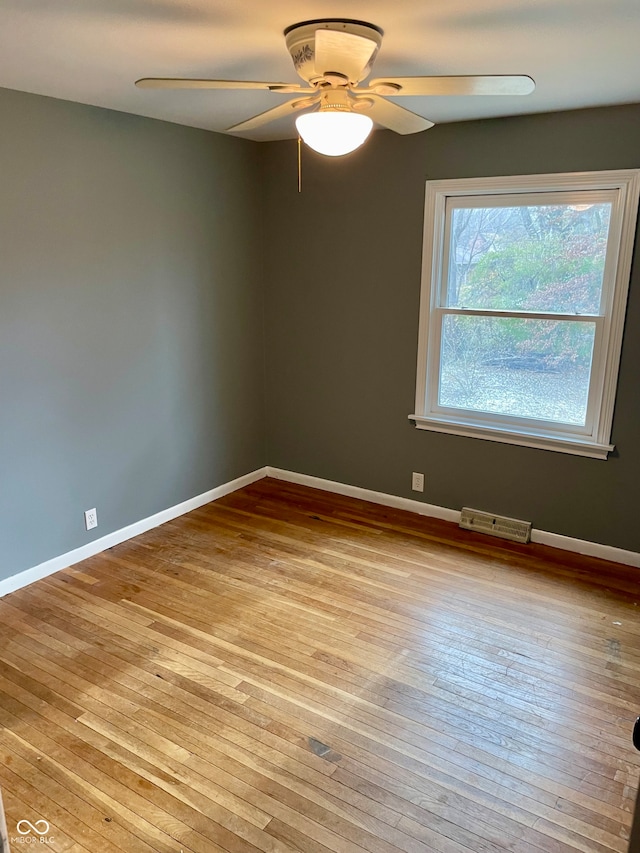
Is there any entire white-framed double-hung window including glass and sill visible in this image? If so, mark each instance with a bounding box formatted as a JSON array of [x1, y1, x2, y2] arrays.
[[410, 170, 640, 459]]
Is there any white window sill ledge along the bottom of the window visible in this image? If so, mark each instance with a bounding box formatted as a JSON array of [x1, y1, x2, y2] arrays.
[[409, 415, 615, 459]]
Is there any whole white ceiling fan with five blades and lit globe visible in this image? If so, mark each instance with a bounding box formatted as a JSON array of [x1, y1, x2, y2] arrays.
[[136, 18, 535, 155]]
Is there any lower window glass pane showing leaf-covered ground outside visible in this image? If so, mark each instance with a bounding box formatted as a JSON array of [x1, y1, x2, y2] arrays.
[[438, 315, 595, 426]]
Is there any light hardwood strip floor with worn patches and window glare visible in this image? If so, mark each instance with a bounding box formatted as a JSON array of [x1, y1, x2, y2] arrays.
[[0, 480, 640, 853]]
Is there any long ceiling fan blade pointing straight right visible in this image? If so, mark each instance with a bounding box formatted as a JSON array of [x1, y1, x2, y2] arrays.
[[359, 74, 536, 97]]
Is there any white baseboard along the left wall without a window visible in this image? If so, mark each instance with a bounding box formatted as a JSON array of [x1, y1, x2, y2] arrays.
[[0, 468, 267, 598]]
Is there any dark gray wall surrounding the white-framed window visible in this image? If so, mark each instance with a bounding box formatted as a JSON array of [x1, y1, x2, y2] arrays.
[[265, 106, 640, 550]]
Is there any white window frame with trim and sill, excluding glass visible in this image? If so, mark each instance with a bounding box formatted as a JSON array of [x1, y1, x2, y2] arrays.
[[409, 169, 640, 459]]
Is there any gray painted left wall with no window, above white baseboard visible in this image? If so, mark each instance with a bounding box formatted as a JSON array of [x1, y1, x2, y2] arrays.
[[0, 90, 266, 579]]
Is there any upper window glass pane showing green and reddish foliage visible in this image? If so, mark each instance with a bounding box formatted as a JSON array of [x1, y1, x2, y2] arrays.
[[445, 202, 611, 314]]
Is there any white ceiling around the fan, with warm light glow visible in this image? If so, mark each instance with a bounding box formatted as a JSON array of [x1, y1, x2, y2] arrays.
[[0, 0, 640, 139]]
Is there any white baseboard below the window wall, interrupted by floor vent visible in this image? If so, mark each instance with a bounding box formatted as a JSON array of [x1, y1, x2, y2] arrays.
[[266, 466, 640, 568]]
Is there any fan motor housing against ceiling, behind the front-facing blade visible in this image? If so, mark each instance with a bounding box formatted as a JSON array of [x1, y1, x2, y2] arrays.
[[284, 18, 384, 84]]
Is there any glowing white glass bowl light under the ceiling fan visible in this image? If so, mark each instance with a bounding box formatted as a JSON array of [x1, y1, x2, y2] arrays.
[[296, 109, 373, 157]]
